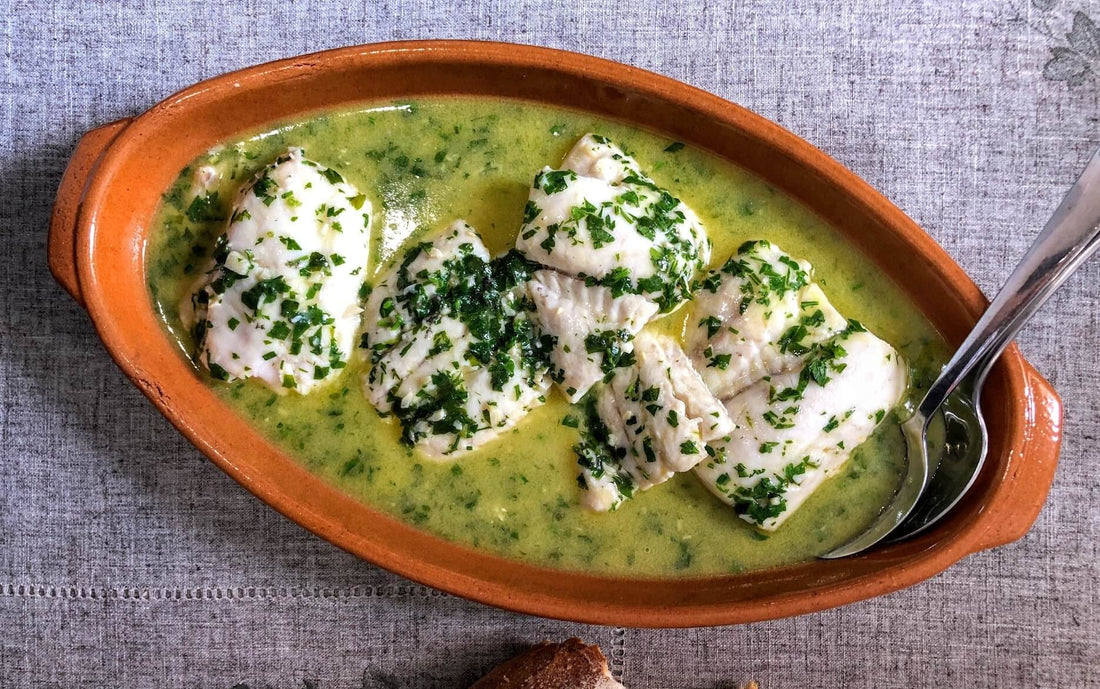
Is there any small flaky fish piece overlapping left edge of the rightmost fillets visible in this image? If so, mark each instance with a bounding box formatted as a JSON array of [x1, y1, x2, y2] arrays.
[[574, 332, 733, 512]]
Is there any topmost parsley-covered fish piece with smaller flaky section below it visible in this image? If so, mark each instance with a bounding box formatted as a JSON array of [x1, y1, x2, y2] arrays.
[[516, 134, 711, 401]]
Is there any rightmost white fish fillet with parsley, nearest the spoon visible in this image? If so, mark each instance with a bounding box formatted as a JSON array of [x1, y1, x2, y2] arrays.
[[695, 330, 908, 531]]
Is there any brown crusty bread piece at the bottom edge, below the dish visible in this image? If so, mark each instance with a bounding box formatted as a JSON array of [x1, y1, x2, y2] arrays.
[[470, 638, 624, 689]]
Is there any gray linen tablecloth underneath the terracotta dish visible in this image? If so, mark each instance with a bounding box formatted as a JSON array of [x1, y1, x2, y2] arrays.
[[0, 0, 1100, 689]]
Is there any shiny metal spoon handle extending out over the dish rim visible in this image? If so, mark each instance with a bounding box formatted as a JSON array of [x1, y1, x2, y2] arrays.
[[919, 149, 1100, 418]]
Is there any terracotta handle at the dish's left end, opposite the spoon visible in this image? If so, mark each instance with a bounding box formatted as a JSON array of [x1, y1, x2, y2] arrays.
[[46, 118, 131, 306]]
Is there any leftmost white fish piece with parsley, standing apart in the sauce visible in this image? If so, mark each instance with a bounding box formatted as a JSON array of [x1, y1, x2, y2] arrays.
[[191, 149, 371, 394]]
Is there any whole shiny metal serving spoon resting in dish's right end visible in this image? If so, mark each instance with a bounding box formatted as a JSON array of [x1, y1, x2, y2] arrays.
[[821, 150, 1100, 559]]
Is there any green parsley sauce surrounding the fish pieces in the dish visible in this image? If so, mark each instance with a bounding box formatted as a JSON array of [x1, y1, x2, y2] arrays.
[[146, 98, 947, 577]]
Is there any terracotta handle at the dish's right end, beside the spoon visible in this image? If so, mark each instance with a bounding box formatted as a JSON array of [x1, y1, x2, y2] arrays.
[[972, 360, 1062, 553]]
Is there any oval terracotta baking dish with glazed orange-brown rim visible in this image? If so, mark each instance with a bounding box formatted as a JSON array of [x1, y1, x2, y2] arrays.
[[50, 41, 1062, 626]]
